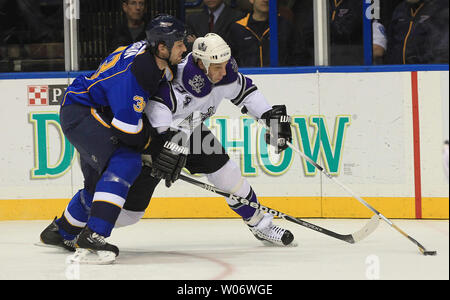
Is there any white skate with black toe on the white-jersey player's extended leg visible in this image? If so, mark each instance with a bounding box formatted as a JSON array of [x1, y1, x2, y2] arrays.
[[246, 213, 297, 247]]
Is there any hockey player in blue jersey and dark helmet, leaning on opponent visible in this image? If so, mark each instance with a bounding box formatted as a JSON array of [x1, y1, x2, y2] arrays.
[[37, 15, 186, 260]]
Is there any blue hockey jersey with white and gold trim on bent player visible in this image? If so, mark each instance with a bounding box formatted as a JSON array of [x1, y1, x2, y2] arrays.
[[61, 41, 169, 134]]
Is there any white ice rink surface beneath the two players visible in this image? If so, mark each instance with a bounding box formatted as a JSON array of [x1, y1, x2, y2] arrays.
[[0, 219, 449, 280]]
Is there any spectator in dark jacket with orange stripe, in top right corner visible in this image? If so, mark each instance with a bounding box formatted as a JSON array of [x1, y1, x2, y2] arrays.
[[386, 0, 449, 64]]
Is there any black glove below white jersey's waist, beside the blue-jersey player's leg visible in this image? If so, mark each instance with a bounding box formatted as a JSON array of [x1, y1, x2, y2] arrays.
[[151, 133, 189, 187]]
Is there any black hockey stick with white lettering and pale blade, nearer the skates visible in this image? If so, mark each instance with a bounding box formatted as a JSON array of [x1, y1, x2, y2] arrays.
[[179, 174, 379, 244]]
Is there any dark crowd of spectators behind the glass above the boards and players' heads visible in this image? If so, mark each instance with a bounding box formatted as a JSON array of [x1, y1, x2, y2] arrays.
[[0, 0, 449, 72]]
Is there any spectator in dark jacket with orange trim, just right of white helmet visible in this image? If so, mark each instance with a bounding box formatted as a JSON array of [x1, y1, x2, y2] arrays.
[[230, 0, 307, 67]]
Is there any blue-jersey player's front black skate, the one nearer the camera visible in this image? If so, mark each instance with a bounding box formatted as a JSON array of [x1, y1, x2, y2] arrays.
[[69, 226, 119, 265]]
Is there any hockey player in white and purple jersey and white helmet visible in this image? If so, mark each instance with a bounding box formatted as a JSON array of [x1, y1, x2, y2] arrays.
[[135, 33, 294, 246]]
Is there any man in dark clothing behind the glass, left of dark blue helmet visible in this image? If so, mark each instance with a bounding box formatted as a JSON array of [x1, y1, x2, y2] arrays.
[[108, 0, 146, 53]]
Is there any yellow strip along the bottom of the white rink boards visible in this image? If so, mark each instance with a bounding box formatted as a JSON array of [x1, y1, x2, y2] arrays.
[[0, 197, 449, 221]]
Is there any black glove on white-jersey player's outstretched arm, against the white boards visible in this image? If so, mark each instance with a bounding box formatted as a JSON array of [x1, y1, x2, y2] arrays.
[[261, 105, 292, 153]]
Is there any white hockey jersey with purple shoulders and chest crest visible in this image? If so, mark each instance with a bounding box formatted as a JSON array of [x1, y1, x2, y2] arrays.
[[145, 54, 272, 133]]
